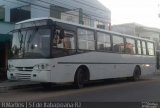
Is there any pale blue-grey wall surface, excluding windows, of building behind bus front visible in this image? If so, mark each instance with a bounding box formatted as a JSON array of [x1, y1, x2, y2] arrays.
[[0, 0, 111, 26]]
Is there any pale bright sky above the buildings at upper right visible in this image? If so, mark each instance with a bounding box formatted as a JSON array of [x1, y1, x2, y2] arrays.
[[99, 0, 160, 29]]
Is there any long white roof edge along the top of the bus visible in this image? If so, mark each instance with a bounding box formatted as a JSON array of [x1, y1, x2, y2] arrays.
[[16, 17, 155, 42]]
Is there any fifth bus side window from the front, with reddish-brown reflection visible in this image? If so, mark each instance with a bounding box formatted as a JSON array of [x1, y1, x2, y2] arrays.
[[125, 38, 136, 54]]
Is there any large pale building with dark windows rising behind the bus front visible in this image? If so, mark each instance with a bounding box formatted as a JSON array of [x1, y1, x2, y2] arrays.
[[0, 0, 111, 29]]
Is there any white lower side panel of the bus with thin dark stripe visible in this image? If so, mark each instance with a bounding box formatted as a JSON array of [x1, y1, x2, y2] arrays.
[[48, 52, 155, 83]]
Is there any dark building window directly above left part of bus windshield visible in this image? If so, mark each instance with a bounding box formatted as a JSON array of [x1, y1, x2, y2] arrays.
[[10, 5, 31, 22]]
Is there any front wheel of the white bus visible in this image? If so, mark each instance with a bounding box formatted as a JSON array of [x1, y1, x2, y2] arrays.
[[74, 68, 86, 89]]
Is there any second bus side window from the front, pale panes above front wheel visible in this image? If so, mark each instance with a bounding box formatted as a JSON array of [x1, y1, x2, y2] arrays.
[[78, 28, 95, 50]]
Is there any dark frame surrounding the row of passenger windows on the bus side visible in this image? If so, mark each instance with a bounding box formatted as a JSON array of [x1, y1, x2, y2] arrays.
[[52, 22, 155, 56]]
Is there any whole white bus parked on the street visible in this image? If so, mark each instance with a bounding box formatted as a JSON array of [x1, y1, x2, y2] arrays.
[[7, 18, 156, 88]]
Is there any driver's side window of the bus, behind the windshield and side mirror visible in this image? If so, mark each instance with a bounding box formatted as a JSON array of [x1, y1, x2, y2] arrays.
[[52, 29, 76, 57]]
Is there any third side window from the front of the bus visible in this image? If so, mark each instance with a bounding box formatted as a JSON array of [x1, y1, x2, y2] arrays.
[[97, 32, 111, 51]]
